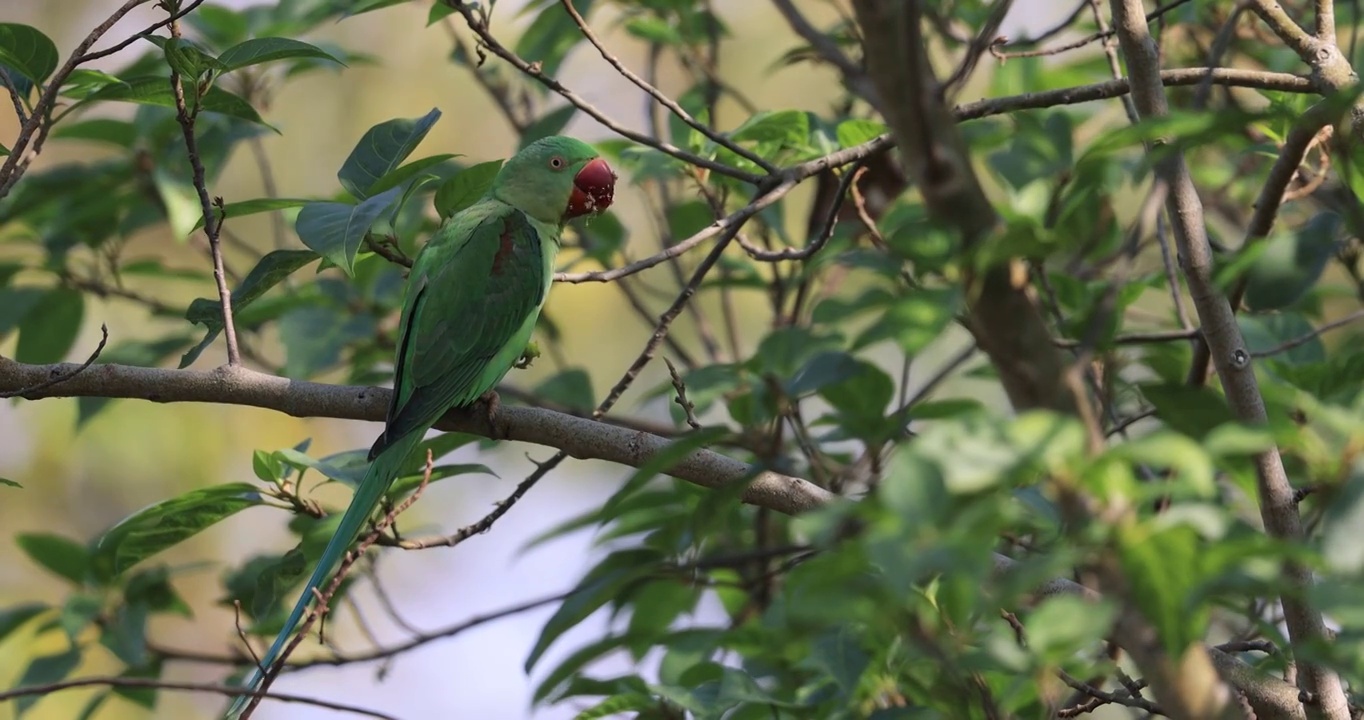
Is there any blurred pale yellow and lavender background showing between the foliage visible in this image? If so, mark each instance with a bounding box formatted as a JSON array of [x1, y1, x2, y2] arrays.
[[0, 0, 1071, 720]]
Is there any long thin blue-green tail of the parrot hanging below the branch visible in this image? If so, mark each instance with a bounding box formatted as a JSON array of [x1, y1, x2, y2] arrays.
[[228, 428, 426, 720]]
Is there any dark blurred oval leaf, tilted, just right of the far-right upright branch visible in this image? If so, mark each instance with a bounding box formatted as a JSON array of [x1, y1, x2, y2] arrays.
[[1245, 210, 1341, 312]]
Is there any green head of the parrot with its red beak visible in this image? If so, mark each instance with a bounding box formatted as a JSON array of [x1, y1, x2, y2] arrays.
[[492, 135, 615, 224]]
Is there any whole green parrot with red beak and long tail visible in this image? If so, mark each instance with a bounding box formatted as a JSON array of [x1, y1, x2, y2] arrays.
[[228, 136, 615, 717]]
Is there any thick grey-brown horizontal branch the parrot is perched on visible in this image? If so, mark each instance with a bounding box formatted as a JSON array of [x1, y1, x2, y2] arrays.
[[0, 357, 835, 514]]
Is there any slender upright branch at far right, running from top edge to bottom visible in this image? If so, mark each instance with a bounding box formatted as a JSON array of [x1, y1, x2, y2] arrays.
[[1112, 0, 1349, 720]]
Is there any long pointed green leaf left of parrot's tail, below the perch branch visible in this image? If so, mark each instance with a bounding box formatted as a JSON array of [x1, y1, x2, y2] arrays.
[[93, 483, 265, 577]]
